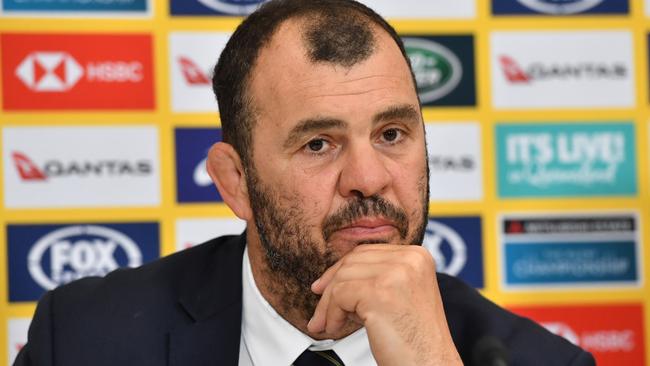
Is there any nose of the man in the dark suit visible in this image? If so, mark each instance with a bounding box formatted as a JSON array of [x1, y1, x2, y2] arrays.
[[339, 143, 392, 198]]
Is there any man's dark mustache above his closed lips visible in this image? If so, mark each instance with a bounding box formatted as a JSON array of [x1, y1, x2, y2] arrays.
[[323, 195, 409, 241]]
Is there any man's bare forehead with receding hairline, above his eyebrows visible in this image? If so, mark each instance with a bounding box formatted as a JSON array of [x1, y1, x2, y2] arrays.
[[249, 20, 418, 132]]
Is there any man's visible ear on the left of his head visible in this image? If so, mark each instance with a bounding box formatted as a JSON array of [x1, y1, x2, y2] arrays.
[[207, 142, 252, 221]]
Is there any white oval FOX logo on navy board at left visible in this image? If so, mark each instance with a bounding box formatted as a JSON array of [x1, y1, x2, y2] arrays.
[[27, 225, 142, 290]]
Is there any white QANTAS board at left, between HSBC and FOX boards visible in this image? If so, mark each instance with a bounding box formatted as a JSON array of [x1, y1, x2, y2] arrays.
[[2, 126, 160, 208]]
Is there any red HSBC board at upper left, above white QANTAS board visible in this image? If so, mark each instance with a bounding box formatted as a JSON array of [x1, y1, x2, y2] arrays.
[[0, 33, 155, 110]]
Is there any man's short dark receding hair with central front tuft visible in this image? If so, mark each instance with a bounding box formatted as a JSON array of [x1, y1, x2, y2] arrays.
[[212, 0, 411, 169]]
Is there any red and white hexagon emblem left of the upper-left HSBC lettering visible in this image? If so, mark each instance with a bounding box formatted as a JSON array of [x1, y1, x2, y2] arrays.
[[16, 52, 84, 92]]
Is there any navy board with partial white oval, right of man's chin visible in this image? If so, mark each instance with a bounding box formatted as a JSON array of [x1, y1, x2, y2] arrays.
[[422, 217, 483, 288]]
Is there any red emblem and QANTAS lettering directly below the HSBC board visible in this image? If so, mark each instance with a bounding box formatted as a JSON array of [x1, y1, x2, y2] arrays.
[[11, 151, 153, 181]]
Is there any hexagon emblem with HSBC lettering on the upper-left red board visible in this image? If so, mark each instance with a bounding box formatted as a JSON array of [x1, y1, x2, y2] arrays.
[[16, 52, 144, 92]]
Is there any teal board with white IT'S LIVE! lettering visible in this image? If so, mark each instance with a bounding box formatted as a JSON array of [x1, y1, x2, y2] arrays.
[[496, 122, 637, 198]]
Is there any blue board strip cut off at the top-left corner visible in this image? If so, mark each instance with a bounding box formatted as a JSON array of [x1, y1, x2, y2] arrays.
[[0, 0, 151, 17]]
